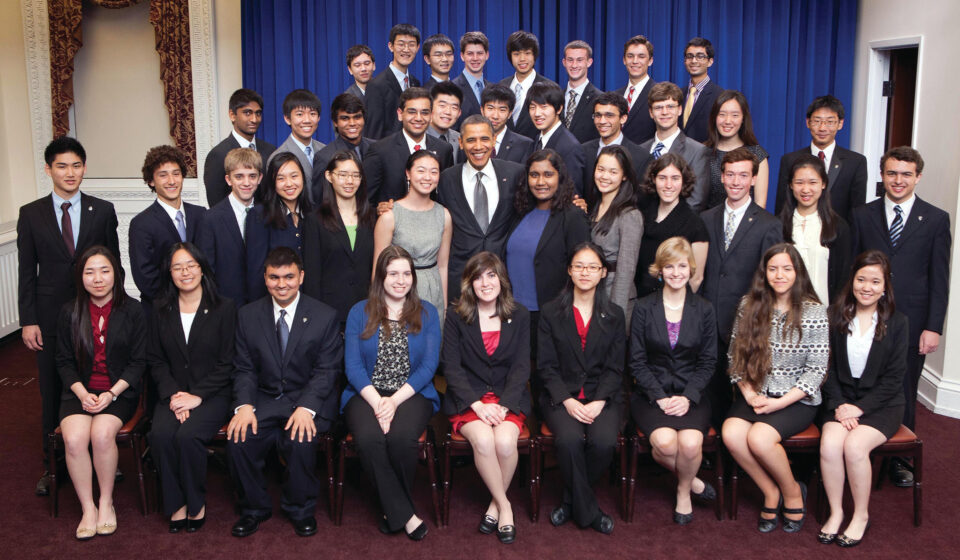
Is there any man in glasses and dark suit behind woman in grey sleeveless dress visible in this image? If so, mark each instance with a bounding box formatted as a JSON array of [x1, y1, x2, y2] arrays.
[[363, 88, 453, 204]]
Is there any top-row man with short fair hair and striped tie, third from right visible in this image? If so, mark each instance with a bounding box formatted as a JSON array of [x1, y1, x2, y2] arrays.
[[560, 40, 601, 144]]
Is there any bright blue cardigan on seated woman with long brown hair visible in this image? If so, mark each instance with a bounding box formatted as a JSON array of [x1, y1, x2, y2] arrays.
[[340, 300, 440, 413]]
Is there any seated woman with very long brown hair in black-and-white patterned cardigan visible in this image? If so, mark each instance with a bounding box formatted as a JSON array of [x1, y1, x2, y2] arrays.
[[723, 243, 830, 533]]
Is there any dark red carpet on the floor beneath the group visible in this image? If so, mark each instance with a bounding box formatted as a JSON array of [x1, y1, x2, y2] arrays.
[[0, 339, 960, 560]]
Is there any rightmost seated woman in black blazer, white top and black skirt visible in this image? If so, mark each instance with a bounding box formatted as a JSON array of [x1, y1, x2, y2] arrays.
[[817, 251, 915, 547]]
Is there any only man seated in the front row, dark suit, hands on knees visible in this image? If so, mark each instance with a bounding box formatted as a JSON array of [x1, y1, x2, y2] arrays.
[[227, 247, 343, 537]]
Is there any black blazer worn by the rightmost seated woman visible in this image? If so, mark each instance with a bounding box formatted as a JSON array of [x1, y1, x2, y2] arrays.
[[821, 312, 910, 419]]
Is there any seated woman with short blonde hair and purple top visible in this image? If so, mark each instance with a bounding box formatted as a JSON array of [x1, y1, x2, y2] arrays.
[[630, 237, 717, 525]]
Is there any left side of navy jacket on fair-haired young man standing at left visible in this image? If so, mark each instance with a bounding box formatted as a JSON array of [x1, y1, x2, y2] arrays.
[[196, 198, 253, 307]]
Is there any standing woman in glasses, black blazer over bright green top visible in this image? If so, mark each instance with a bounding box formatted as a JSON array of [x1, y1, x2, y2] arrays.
[[303, 151, 377, 332]]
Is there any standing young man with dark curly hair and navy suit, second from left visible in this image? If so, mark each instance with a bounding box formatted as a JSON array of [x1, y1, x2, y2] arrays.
[[128, 146, 206, 317]]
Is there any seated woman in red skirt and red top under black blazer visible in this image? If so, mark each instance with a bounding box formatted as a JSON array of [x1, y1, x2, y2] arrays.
[[443, 251, 530, 543]]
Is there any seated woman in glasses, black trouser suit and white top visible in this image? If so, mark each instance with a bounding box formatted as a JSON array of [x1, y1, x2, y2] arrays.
[[147, 243, 237, 533]]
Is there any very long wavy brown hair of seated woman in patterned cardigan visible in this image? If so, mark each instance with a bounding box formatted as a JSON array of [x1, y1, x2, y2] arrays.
[[730, 243, 820, 389]]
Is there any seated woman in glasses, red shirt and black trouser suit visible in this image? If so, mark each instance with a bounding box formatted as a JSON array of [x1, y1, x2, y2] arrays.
[[537, 241, 627, 534]]
